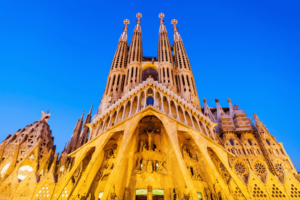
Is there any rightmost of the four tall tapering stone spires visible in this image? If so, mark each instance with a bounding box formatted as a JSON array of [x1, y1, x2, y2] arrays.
[[172, 19, 201, 110]]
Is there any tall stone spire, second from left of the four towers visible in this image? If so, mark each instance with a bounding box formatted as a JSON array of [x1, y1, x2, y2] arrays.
[[126, 13, 143, 91]]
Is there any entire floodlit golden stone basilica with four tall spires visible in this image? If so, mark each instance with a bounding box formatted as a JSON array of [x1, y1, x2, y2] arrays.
[[0, 13, 300, 200]]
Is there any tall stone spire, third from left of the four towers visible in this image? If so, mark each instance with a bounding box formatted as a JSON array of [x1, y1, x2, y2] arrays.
[[158, 13, 176, 91]]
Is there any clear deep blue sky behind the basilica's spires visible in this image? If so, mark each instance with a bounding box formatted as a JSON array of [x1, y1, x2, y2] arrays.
[[0, 0, 300, 170]]
